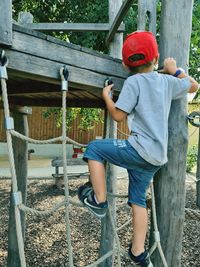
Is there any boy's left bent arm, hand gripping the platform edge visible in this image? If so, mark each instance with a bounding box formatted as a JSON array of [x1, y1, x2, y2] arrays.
[[102, 84, 127, 122]]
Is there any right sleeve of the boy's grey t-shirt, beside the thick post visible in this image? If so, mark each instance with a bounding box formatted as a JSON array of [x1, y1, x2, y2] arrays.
[[171, 76, 191, 100]]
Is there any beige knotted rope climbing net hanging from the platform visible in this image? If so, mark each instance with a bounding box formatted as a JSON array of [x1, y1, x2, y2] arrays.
[[4, 50, 200, 267]]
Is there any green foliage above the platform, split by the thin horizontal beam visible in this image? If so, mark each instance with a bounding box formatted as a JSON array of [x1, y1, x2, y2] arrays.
[[13, 0, 108, 53]]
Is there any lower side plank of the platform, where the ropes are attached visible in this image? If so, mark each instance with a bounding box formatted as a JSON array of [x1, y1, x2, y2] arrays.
[[6, 50, 124, 96]]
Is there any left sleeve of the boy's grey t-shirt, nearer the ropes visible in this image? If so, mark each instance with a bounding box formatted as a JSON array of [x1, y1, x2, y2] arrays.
[[115, 79, 139, 114]]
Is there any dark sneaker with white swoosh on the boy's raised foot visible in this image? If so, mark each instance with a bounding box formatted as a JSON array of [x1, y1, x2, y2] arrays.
[[78, 183, 108, 219]]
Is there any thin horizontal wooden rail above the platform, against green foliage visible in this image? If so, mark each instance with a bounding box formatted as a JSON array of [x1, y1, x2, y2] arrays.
[[22, 23, 125, 32]]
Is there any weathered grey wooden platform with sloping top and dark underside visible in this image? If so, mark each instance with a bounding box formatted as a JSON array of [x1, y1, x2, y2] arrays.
[[0, 25, 127, 107]]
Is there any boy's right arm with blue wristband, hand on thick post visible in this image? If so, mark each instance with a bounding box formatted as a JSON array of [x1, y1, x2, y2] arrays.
[[164, 58, 199, 93]]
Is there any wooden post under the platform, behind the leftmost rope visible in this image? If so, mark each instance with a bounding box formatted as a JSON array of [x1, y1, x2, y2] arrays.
[[7, 107, 31, 267]]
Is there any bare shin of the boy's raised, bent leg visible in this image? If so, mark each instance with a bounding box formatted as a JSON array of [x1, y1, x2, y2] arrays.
[[88, 160, 106, 202]]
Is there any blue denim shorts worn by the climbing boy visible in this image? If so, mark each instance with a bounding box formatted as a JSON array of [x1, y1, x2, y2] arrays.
[[83, 139, 160, 208]]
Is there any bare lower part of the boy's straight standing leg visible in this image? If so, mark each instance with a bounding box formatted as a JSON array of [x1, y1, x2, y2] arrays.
[[132, 204, 148, 256]]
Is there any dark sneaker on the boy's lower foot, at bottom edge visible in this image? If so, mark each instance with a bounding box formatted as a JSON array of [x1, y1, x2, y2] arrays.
[[128, 245, 153, 267]]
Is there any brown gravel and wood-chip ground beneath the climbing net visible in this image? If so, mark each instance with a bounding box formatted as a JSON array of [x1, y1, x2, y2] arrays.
[[0, 175, 200, 267]]
